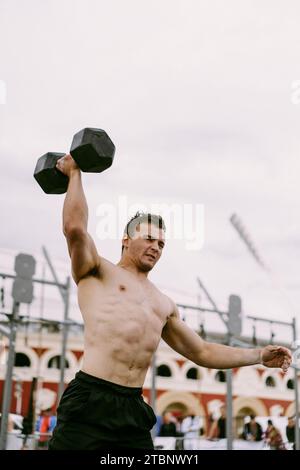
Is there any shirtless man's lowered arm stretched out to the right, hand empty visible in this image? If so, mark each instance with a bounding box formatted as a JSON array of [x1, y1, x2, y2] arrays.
[[162, 305, 292, 372]]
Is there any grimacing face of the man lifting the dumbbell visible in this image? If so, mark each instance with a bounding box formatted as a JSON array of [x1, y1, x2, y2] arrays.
[[124, 222, 165, 272]]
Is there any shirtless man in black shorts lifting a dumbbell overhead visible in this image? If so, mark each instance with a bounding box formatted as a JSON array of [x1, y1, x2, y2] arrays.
[[49, 155, 291, 450]]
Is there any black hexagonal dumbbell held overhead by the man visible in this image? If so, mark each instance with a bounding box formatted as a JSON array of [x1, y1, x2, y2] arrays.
[[33, 127, 115, 194]]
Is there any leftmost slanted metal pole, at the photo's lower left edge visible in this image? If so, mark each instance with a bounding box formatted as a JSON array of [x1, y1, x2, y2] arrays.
[[0, 302, 19, 450]]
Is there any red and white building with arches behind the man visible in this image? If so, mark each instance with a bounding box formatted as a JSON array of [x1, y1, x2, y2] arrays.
[[0, 330, 295, 433]]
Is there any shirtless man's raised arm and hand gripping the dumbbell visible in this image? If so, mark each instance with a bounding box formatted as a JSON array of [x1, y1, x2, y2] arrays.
[[56, 155, 100, 284]]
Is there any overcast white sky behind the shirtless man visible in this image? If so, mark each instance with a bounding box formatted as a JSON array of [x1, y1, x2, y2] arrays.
[[0, 0, 300, 344]]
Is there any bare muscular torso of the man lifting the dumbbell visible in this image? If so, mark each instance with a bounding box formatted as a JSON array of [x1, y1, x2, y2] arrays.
[[78, 258, 173, 387]]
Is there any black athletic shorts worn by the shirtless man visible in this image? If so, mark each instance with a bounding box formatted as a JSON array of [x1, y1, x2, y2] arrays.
[[49, 371, 156, 450]]
